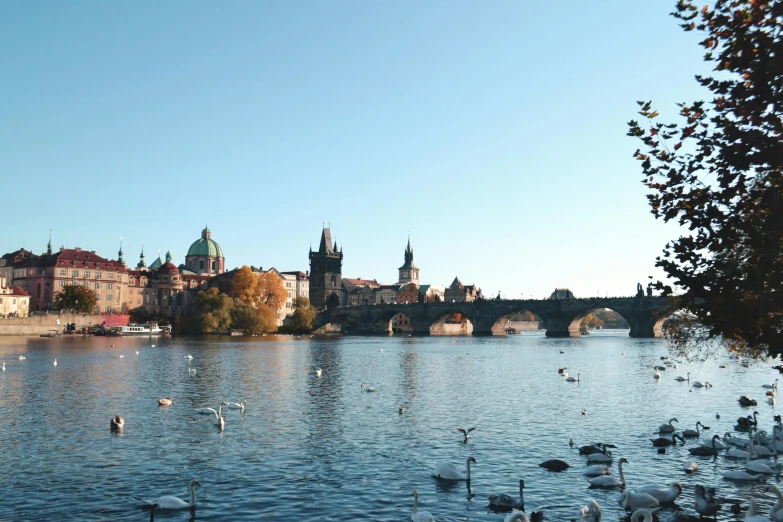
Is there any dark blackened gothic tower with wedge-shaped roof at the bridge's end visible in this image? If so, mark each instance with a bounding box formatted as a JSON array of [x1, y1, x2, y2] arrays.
[[310, 227, 343, 309]]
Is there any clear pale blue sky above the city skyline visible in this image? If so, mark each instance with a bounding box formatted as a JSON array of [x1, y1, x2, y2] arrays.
[[0, 0, 707, 297]]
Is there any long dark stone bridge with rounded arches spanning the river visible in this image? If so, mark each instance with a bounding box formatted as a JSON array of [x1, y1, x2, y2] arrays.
[[315, 297, 672, 337]]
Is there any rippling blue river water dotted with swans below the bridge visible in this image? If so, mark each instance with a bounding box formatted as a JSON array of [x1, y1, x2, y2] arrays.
[[0, 332, 778, 521]]
